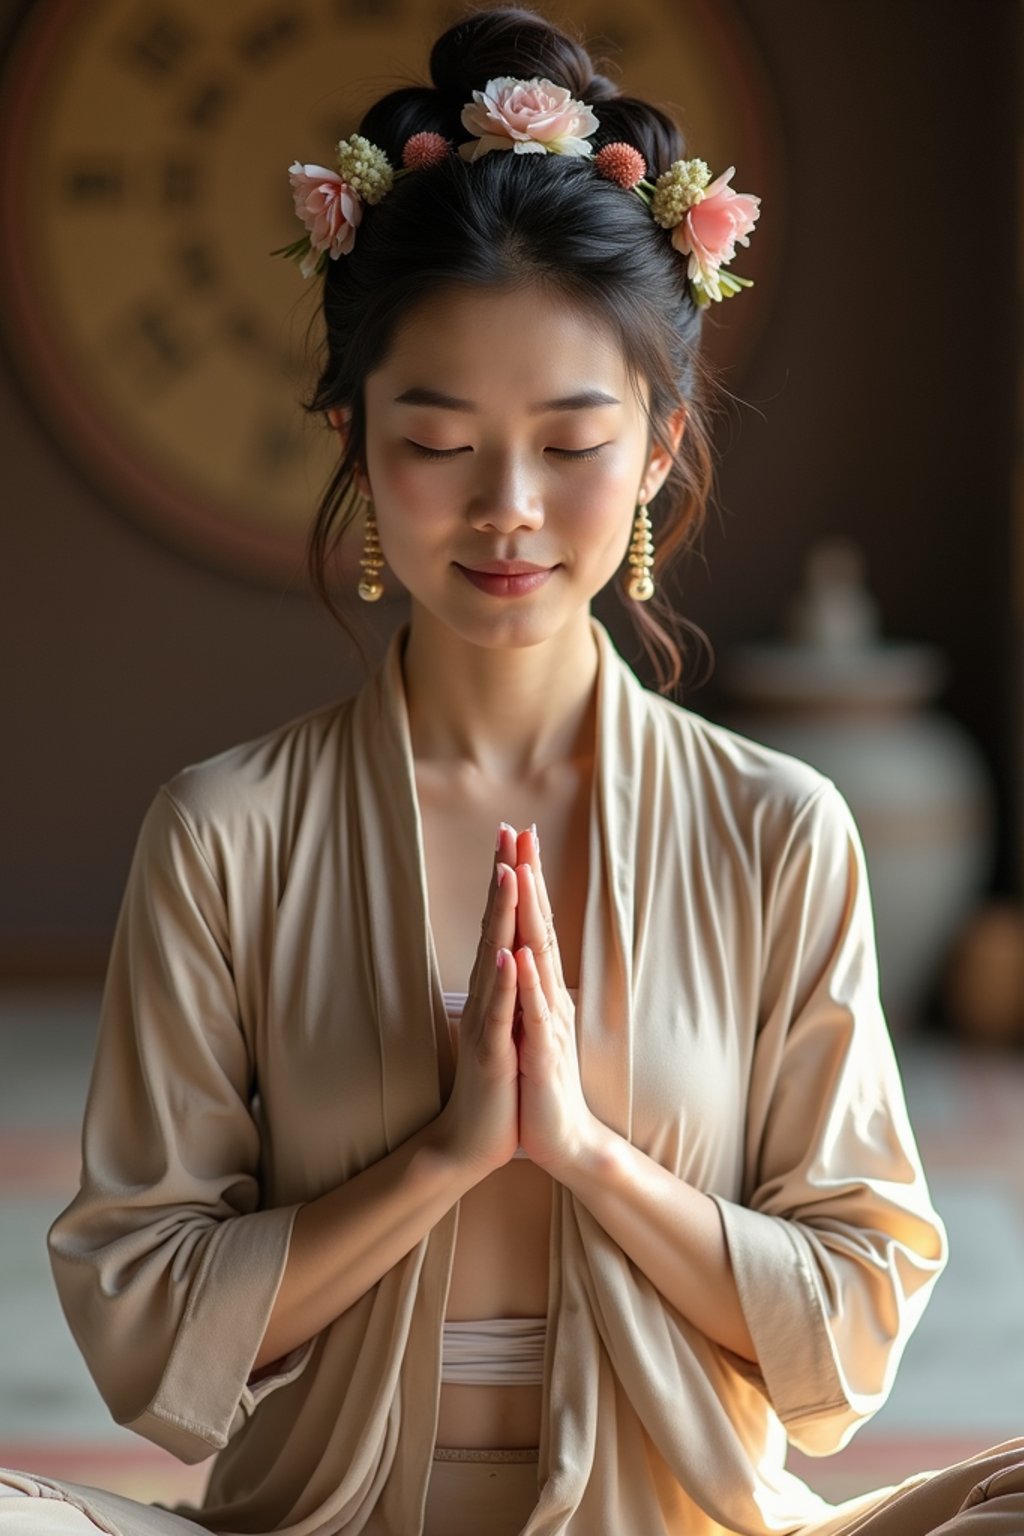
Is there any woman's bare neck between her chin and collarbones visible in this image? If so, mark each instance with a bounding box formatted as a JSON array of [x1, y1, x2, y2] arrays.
[[402, 604, 597, 782]]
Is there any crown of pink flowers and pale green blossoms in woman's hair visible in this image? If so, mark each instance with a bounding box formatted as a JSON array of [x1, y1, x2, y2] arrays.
[[273, 75, 761, 307]]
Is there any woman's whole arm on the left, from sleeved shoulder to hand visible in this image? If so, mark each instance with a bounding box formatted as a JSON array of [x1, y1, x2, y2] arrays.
[[49, 791, 516, 1461]]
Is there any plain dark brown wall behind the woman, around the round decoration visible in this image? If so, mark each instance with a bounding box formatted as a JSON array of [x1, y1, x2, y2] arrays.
[[0, 0, 1021, 971]]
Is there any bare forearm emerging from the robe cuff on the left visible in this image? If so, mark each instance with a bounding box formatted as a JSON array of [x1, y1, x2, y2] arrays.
[[253, 1120, 482, 1370]]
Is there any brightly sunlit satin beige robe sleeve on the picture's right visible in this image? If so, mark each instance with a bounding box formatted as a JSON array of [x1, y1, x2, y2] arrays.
[[715, 780, 946, 1456]]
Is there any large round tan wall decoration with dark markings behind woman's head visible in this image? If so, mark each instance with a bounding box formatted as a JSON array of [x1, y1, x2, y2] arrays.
[[0, 0, 781, 585]]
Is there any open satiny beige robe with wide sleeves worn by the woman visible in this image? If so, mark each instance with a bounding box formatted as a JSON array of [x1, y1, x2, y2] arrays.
[[51, 619, 946, 1536]]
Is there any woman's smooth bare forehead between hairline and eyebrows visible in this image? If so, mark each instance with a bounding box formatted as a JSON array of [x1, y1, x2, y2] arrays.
[[378, 287, 628, 401]]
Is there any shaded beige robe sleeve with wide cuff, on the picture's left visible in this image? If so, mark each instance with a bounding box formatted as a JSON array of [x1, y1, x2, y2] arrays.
[[49, 790, 312, 1462]]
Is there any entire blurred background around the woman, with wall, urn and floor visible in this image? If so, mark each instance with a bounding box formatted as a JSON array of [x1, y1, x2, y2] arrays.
[[0, 0, 1024, 1498]]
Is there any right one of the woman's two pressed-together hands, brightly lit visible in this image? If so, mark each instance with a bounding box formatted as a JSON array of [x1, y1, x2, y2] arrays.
[[516, 833, 596, 1178]]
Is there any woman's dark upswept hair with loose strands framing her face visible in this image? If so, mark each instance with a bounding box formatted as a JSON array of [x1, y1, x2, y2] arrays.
[[309, 8, 712, 693]]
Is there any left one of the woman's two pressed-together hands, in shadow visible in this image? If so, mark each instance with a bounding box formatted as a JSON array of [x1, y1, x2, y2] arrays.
[[439, 823, 519, 1178]]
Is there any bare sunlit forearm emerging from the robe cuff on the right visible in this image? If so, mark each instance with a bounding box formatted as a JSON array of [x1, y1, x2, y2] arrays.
[[554, 1121, 757, 1361]]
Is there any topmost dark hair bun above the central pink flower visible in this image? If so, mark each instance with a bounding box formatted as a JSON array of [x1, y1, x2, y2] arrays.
[[430, 6, 601, 101]]
